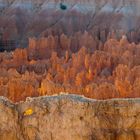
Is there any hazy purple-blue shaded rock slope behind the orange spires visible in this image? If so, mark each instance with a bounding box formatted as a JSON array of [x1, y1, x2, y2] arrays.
[[0, 0, 140, 47]]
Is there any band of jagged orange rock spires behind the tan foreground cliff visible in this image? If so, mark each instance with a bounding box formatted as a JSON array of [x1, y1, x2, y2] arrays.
[[0, 36, 140, 102]]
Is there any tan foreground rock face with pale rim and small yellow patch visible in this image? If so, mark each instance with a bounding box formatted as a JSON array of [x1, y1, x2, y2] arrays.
[[0, 95, 140, 140]]
